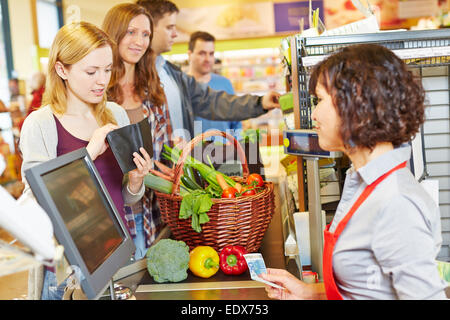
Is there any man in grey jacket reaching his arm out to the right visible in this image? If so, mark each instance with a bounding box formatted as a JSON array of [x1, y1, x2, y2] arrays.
[[137, 0, 280, 140]]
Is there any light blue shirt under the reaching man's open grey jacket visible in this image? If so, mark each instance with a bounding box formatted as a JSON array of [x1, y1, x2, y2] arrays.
[[155, 55, 186, 141]]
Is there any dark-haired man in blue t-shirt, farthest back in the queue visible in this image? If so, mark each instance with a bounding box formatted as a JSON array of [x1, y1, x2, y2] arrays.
[[187, 31, 242, 141]]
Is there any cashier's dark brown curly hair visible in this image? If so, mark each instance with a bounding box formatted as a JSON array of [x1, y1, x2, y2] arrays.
[[309, 44, 425, 150]]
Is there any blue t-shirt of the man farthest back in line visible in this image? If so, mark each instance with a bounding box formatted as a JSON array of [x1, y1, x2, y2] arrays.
[[195, 73, 242, 142]]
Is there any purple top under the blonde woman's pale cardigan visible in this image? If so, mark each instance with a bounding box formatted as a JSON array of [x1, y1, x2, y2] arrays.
[[54, 116, 127, 226]]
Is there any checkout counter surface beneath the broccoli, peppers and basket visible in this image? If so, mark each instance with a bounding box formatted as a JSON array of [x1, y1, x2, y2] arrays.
[[115, 181, 300, 300]]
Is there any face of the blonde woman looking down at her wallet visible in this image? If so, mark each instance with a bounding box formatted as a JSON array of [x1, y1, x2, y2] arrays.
[[56, 46, 113, 104]]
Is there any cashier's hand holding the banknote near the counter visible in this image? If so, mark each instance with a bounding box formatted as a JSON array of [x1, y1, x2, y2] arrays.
[[260, 268, 314, 300]]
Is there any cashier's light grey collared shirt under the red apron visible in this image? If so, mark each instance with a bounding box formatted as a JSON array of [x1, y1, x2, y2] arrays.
[[330, 145, 447, 300]]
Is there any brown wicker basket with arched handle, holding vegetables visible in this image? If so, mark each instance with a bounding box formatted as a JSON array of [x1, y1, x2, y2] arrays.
[[155, 130, 275, 252]]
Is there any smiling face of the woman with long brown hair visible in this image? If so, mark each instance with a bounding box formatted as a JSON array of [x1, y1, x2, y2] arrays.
[[119, 14, 151, 64]]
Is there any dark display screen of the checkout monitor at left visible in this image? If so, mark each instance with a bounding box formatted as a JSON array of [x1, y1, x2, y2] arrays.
[[42, 159, 124, 273]]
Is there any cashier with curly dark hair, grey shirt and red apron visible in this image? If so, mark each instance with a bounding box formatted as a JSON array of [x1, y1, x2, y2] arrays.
[[262, 44, 446, 300]]
